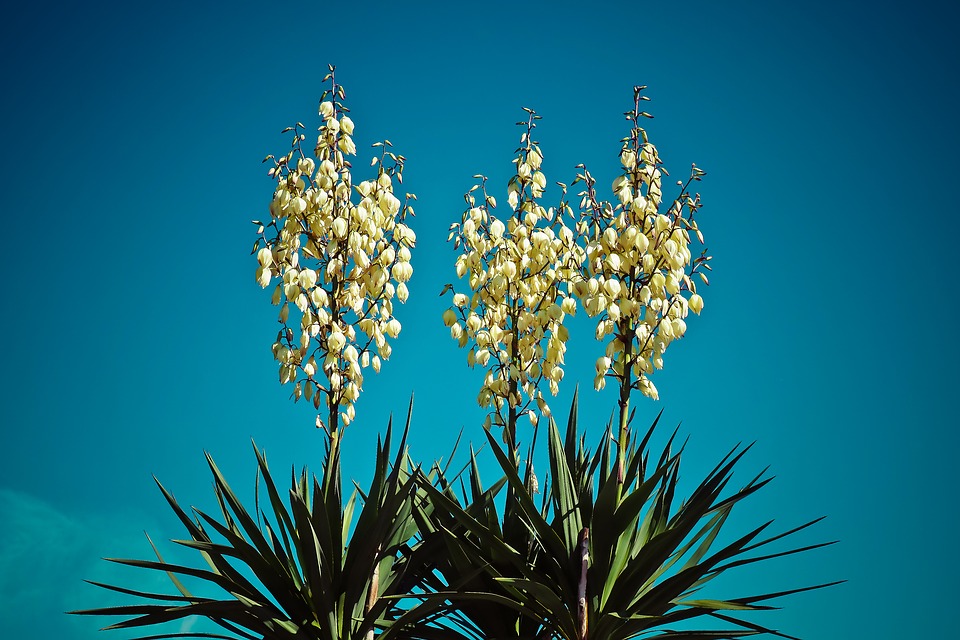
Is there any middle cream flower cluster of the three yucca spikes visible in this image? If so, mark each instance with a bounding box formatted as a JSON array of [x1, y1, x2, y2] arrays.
[[443, 109, 583, 445]]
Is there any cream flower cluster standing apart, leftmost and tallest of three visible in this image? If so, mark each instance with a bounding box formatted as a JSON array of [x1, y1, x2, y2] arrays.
[[253, 66, 416, 432]]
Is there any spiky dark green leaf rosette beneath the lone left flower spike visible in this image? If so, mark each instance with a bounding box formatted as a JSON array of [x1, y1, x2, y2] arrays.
[[73, 404, 446, 640]]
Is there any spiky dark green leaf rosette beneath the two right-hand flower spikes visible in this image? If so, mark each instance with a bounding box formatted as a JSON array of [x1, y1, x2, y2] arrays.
[[408, 390, 835, 640]]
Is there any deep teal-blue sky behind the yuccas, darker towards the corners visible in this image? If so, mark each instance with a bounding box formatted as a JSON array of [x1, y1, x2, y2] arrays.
[[0, 1, 960, 640]]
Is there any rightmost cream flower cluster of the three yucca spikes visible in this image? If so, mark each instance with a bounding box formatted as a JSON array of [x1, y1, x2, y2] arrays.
[[574, 87, 710, 399]]
